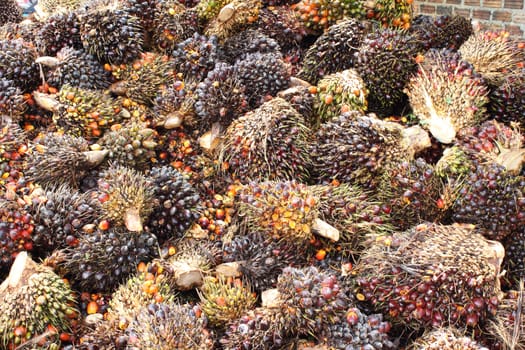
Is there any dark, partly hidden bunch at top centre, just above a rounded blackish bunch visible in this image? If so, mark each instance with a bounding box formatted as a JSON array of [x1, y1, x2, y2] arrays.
[[221, 29, 281, 64]]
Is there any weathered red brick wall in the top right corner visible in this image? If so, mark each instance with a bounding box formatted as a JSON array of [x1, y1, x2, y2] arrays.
[[414, 0, 525, 37]]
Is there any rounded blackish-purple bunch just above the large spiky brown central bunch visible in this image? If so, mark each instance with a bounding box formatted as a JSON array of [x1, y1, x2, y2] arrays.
[[234, 52, 291, 108]]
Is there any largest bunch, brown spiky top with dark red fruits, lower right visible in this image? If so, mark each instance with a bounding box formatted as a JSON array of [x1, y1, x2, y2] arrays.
[[352, 223, 505, 329]]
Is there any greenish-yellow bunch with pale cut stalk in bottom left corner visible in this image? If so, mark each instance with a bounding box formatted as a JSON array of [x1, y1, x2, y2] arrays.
[[0, 252, 78, 349]]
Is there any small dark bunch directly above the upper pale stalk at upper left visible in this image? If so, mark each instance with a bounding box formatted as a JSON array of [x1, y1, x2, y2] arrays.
[[35, 11, 82, 56]]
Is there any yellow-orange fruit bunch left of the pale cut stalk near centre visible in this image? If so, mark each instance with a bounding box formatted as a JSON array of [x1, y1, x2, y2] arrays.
[[236, 181, 318, 246]]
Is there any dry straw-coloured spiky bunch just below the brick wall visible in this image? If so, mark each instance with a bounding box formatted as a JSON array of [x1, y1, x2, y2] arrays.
[[458, 31, 523, 87]]
